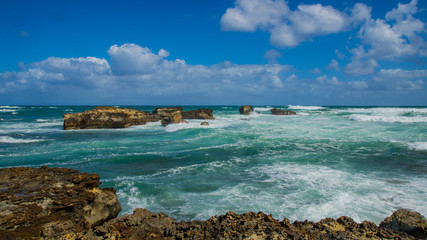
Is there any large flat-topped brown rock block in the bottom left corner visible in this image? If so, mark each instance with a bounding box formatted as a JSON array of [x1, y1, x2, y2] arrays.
[[0, 167, 121, 239]]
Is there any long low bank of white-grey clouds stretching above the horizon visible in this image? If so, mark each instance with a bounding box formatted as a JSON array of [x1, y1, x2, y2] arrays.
[[0, 43, 427, 104]]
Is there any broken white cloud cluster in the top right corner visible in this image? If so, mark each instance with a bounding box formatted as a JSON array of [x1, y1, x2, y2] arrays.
[[345, 0, 427, 75]]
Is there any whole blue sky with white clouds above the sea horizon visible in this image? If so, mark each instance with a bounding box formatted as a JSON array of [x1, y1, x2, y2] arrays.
[[0, 0, 427, 106]]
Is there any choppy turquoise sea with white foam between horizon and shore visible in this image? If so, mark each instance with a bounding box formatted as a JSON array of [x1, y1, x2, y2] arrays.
[[0, 106, 427, 223]]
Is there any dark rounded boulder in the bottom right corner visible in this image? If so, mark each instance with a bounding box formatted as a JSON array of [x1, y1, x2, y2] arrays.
[[380, 209, 427, 239]]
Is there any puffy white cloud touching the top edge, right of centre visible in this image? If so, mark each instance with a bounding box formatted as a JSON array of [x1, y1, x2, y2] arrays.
[[221, 0, 352, 47]]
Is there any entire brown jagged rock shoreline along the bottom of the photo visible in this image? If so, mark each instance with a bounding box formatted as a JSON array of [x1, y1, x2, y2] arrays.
[[0, 167, 427, 240]]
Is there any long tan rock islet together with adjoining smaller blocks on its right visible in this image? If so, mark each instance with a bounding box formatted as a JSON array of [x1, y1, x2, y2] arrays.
[[63, 107, 214, 130]]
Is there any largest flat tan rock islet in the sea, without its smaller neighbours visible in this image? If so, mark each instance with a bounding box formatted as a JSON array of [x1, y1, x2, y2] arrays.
[[63, 107, 156, 130]]
